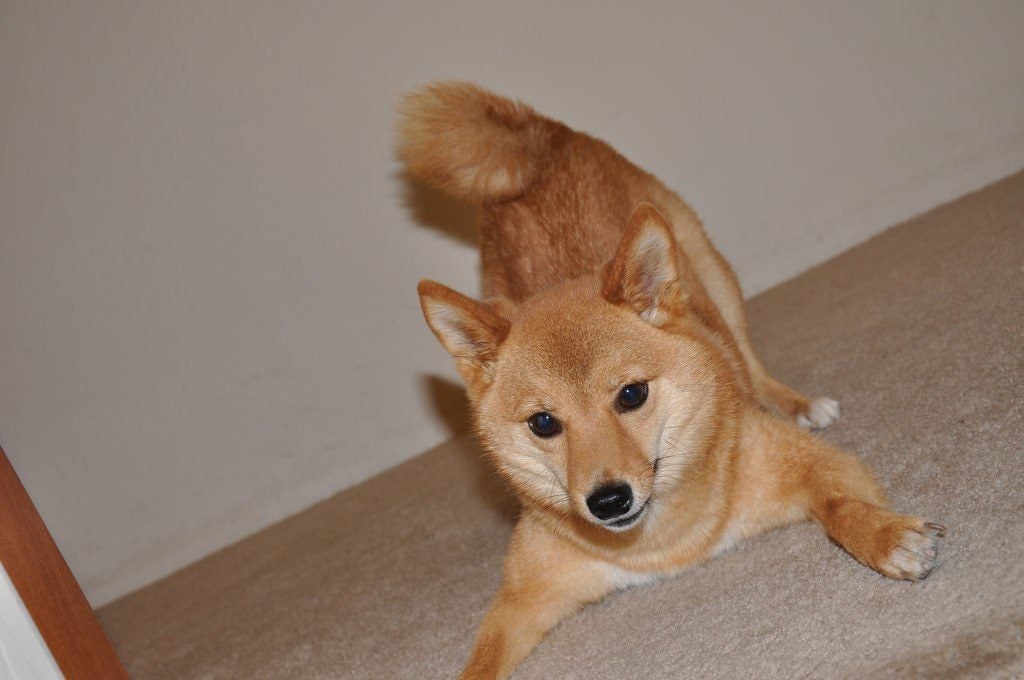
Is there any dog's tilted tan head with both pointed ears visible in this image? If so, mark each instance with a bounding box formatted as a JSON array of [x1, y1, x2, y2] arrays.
[[419, 205, 728, 532]]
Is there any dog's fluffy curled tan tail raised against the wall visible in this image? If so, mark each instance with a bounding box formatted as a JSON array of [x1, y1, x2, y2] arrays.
[[398, 82, 556, 203]]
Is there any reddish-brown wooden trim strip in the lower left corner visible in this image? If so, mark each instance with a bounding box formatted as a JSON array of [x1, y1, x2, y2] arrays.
[[0, 449, 128, 680]]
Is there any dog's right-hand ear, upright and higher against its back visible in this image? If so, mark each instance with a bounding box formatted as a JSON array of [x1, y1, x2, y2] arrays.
[[601, 203, 686, 326]]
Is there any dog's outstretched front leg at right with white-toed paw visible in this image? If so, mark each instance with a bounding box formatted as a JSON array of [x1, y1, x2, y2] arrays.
[[737, 414, 945, 581]]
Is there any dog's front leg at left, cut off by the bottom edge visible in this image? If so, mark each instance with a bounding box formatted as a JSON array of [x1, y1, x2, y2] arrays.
[[461, 517, 614, 680]]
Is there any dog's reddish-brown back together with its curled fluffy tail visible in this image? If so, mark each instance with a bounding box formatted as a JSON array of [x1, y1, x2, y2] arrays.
[[399, 83, 710, 300]]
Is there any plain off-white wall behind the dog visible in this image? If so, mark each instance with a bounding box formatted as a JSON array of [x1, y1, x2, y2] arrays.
[[0, 0, 1024, 603]]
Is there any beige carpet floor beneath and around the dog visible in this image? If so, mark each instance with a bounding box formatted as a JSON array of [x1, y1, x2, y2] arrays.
[[99, 173, 1024, 680]]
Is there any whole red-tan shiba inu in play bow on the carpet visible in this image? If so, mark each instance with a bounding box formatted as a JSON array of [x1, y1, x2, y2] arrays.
[[398, 83, 944, 678]]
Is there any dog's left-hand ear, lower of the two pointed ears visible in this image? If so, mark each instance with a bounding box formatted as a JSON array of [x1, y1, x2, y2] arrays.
[[416, 280, 512, 396]]
